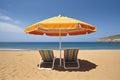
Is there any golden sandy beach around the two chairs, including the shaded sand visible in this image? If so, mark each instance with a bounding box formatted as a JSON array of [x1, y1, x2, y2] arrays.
[[0, 50, 120, 80]]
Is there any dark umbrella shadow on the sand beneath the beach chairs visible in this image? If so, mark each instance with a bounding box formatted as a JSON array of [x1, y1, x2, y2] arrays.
[[38, 58, 97, 72]]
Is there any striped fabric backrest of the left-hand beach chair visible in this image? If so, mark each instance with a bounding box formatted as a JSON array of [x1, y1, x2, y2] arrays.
[[39, 50, 54, 62]]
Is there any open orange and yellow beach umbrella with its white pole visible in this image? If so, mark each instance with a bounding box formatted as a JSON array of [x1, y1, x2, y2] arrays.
[[25, 15, 96, 66]]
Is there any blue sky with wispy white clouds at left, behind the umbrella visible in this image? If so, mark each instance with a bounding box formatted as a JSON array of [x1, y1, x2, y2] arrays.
[[0, 0, 120, 42]]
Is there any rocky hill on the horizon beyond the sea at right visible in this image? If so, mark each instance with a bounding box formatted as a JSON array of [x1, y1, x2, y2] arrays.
[[97, 34, 120, 42]]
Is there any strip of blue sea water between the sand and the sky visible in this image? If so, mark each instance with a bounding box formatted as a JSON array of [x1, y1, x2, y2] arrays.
[[0, 42, 120, 50]]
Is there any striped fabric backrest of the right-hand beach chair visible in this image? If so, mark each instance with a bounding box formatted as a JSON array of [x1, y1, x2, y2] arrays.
[[64, 49, 78, 62]]
